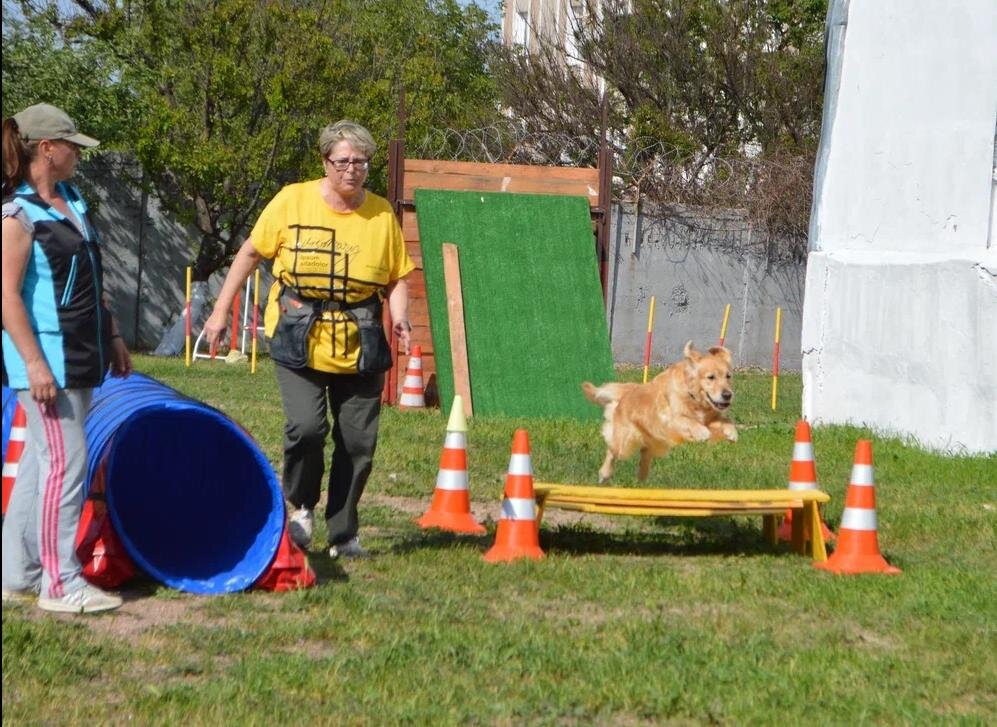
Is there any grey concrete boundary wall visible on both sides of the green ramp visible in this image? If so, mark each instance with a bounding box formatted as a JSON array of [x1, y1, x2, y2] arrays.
[[79, 154, 804, 371]]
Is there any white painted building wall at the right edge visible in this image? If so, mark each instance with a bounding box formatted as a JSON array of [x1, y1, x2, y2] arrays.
[[801, 0, 997, 452]]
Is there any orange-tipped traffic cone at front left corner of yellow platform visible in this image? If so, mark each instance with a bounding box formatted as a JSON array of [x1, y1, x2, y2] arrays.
[[485, 429, 543, 563]]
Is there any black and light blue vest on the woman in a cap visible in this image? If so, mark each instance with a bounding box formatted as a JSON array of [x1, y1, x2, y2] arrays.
[[3, 182, 111, 389]]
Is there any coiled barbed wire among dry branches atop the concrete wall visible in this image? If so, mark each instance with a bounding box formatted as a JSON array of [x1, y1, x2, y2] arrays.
[[406, 120, 814, 260]]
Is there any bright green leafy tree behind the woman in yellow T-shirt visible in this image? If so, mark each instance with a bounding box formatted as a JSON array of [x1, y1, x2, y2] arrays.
[[4, 0, 497, 280]]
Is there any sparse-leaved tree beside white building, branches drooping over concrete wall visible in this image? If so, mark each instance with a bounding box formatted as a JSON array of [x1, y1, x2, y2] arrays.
[[493, 0, 827, 256]]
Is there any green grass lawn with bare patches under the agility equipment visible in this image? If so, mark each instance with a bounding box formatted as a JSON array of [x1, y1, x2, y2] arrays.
[[3, 356, 997, 725]]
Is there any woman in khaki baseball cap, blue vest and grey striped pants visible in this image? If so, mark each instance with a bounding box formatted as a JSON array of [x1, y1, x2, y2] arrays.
[[2, 104, 132, 613]]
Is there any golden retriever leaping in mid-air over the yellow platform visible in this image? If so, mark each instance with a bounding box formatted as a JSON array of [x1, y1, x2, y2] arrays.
[[582, 341, 737, 482]]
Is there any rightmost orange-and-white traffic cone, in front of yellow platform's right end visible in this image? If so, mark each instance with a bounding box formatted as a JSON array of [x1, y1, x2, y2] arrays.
[[814, 439, 900, 575]]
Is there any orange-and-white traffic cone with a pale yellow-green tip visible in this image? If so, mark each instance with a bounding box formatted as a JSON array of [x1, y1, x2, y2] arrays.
[[416, 394, 485, 534]]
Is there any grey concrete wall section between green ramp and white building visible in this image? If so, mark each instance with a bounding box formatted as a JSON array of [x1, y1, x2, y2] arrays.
[[607, 205, 804, 371]]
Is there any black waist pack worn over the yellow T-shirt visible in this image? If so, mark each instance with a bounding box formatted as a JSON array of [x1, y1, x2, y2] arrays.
[[270, 286, 392, 374]]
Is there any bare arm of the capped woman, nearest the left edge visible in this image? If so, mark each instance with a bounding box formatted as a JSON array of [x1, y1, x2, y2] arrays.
[[2, 217, 57, 405]]
